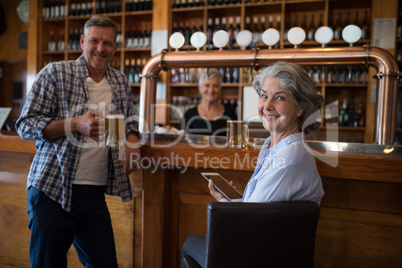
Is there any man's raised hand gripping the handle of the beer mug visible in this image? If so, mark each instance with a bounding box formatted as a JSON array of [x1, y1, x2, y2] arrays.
[[71, 110, 105, 141]]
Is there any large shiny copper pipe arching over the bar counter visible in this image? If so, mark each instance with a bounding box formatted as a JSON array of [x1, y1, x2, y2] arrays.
[[140, 46, 399, 147]]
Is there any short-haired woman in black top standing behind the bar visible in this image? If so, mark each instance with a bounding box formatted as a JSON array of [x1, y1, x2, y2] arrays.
[[180, 68, 237, 136]]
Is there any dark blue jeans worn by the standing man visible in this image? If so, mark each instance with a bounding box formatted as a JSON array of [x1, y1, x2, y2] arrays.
[[27, 185, 117, 268]]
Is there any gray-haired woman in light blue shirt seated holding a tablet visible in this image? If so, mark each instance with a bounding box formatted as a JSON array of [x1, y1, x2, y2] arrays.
[[182, 62, 324, 267]]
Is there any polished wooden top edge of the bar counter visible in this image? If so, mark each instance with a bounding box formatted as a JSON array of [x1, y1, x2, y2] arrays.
[[0, 134, 402, 183]]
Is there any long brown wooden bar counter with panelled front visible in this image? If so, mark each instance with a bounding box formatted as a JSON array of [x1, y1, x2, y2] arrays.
[[0, 133, 402, 267]]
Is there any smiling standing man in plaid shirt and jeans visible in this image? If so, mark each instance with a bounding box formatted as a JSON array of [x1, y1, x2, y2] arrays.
[[16, 15, 140, 268]]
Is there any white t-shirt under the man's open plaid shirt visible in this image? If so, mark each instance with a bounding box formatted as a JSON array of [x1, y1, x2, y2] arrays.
[[74, 77, 113, 185]]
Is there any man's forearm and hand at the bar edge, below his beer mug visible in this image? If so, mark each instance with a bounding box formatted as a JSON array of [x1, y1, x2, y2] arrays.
[[114, 133, 141, 176]]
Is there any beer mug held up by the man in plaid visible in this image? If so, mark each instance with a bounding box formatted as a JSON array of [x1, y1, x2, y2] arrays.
[[105, 114, 126, 147]]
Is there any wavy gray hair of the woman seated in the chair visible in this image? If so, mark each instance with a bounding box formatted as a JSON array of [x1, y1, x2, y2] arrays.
[[253, 61, 324, 134]]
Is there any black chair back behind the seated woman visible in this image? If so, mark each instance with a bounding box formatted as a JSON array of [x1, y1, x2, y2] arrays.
[[205, 201, 320, 268]]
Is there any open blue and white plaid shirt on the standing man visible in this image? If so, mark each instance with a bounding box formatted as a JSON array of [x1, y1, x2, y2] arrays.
[[16, 55, 140, 211]]
